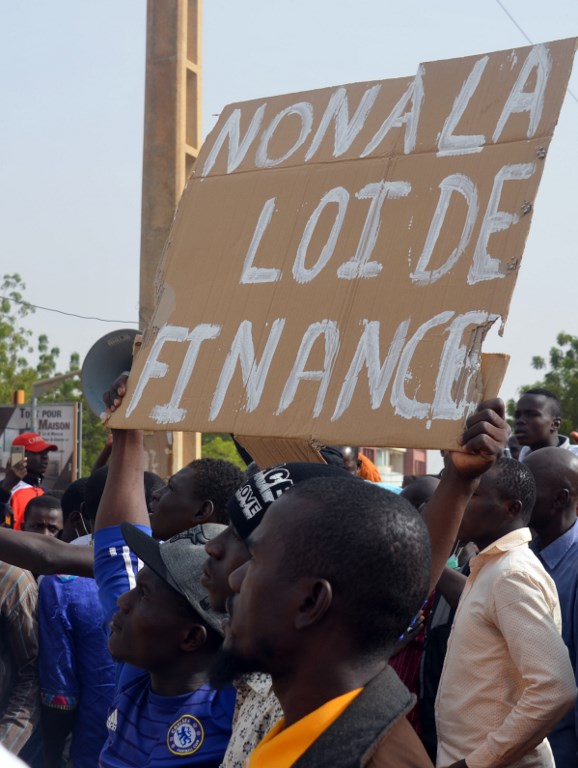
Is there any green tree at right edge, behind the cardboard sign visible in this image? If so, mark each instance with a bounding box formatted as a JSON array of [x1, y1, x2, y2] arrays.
[[508, 332, 578, 435]]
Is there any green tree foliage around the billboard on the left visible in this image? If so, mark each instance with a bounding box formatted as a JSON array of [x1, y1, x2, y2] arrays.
[[0, 273, 106, 475]]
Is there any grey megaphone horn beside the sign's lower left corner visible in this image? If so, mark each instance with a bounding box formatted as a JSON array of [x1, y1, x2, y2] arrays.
[[80, 328, 141, 416]]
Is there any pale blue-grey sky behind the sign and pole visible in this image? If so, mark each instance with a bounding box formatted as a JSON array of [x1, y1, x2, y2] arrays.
[[0, 0, 578, 420]]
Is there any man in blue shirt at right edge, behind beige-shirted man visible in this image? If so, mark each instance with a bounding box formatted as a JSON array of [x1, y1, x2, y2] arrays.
[[525, 448, 578, 766]]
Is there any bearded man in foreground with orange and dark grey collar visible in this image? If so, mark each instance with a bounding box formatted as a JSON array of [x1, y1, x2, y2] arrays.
[[215, 477, 430, 768]]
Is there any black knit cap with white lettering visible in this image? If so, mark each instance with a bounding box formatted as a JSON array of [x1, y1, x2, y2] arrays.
[[227, 461, 348, 539]]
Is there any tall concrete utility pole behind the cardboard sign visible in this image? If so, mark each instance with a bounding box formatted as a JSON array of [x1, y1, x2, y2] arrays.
[[139, 0, 202, 476]]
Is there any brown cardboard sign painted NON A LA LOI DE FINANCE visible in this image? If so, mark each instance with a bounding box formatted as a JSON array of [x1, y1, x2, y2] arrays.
[[110, 39, 575, 448]]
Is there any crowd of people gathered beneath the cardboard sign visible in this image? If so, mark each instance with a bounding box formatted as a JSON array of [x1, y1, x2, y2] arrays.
[[0, 388, 578, 768]]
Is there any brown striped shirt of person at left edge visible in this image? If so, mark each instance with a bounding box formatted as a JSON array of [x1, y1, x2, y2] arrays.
[[0, 561, 40, 754]]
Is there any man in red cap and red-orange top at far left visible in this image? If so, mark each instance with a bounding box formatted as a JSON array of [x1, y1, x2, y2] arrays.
[[0, 432, 58, 530]]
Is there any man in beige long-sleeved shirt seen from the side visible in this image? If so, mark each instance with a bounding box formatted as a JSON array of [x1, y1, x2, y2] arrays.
[[436, 459, 576, 768]]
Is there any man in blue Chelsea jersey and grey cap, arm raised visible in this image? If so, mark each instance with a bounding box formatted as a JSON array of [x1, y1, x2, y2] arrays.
[[94, 430, 235, 768]]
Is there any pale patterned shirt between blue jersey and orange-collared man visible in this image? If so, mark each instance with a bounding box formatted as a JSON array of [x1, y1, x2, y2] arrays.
[[221, 672, 283, 768]]
